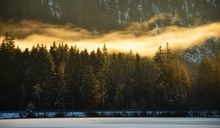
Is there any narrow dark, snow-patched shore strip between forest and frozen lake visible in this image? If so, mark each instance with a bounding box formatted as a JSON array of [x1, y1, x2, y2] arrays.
[[0, 110, 220, 119]]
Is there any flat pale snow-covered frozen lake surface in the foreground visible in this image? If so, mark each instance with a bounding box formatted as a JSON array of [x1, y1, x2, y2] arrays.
[[0, 117, 220, 128]]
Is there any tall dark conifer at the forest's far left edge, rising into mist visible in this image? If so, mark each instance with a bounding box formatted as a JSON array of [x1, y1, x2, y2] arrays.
[[0, 33, 20, 110]]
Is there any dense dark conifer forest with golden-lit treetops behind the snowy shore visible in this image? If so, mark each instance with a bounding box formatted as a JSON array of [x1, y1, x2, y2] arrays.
[[0, 34, 220, 111]]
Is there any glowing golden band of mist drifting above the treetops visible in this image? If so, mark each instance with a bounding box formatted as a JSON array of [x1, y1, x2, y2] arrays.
[[0, 20, 220, 56]]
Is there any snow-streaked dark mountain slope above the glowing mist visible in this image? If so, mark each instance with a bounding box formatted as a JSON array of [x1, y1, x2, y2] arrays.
[[0, 0, 220, 31]]
